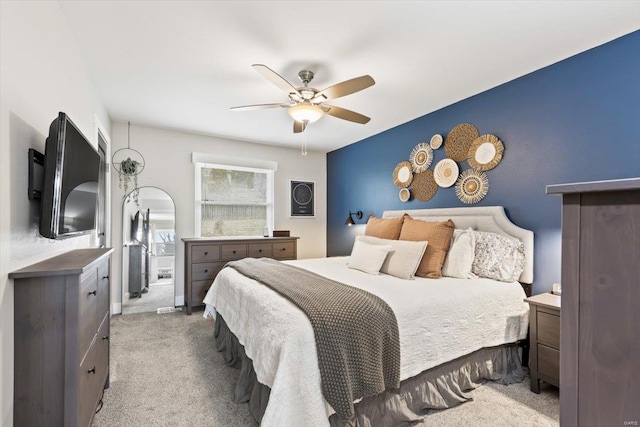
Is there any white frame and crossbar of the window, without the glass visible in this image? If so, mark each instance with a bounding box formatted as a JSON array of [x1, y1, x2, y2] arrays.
[[194, 162, 275, 238]]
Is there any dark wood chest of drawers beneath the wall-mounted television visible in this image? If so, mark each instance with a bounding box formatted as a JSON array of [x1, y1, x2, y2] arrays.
[[9, 248, 113, 427]]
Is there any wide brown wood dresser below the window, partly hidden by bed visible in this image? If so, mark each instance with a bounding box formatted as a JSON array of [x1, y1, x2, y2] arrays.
[[182, 237, 298, 314]]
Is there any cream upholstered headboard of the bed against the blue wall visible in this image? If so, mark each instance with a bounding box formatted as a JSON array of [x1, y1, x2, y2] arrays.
[[382, 206, 533, 284]]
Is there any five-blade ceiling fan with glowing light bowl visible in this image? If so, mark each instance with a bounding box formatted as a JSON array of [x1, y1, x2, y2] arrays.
[[231, 64, 375, 133]]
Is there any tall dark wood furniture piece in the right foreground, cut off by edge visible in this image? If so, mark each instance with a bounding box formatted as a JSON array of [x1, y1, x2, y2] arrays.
[[547, 178, 640, 427]]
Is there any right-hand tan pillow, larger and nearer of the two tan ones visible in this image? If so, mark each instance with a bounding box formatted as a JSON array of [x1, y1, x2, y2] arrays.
[[400, 215, 455, 279]]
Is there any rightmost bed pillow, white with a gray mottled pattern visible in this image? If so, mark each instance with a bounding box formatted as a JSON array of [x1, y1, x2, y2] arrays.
[[471, 231, 524, 282]]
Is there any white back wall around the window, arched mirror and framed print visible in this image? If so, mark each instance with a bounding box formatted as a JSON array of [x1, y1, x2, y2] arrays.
[[111, 123, 327, 308]]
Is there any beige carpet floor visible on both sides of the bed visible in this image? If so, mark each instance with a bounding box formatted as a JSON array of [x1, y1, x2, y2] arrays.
[[93, 312, 559, 427]]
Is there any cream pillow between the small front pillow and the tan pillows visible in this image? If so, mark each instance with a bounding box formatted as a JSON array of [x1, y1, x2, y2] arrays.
[[356, 236, 427, 279]]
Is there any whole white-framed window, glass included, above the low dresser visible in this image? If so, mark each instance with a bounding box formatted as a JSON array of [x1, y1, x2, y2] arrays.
[[195, 163, 273, 237]]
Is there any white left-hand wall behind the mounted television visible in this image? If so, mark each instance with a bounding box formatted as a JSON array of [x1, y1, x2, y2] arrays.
[[0, 1, 110, 426]]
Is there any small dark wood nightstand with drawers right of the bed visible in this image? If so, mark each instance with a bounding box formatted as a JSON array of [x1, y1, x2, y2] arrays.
[[525, 293, 560, 393]]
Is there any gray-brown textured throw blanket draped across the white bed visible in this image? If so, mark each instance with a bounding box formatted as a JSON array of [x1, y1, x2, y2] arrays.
[[227, 258, 400, 420]]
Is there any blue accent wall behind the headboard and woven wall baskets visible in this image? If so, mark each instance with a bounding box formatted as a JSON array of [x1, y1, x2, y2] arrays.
[[327, 31, 640, 294]]
